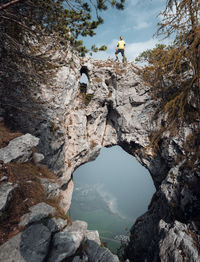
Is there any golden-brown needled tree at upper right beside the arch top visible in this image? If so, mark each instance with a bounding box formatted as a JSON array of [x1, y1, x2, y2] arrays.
[[136, 0, 200, 124]]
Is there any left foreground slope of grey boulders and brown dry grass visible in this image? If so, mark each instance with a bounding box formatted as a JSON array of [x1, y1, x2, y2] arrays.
[[0, 134, 119, 262]]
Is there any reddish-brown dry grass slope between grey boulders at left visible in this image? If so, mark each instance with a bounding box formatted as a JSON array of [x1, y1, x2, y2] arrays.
[[0, 163, 69, 245]]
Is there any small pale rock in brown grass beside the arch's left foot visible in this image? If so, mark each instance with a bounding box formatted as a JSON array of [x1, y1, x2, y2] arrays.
[[40, 178, 60, 198]]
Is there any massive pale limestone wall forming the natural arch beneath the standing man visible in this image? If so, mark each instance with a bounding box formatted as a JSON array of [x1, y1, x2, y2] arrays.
[[0, 41, 200, 262]]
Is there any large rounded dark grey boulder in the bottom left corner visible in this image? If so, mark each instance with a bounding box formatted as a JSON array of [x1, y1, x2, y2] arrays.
[[0, 224, 51, 262]]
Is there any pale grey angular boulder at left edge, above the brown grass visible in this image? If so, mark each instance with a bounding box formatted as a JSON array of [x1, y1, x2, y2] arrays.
[[0, 134, 39, 163]]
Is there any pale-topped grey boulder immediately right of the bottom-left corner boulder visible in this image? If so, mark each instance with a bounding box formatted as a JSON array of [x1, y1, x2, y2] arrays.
[[48, 220, 87, 262]]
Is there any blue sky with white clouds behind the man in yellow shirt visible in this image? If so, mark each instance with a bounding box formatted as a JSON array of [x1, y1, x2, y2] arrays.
[[84, 0, 166, 61]]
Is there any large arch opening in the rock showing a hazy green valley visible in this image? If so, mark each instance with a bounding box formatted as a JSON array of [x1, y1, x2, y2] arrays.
[[70, 146, 155, 252]]
